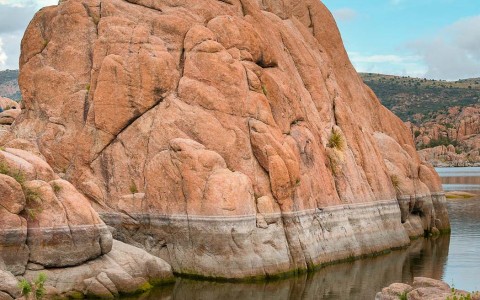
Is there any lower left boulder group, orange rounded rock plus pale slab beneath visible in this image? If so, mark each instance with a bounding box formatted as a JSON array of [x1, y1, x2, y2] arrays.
[[0, 143, 173, 300]]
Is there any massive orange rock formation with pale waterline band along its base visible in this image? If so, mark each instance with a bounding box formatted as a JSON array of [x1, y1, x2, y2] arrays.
[[6, 0, 449, 278]]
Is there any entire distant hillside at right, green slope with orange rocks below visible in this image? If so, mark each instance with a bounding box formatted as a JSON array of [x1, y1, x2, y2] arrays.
[[360, 73, 480, 166]]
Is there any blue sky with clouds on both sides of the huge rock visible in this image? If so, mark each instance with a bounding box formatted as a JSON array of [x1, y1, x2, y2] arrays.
[[0, 0, 480, 80]]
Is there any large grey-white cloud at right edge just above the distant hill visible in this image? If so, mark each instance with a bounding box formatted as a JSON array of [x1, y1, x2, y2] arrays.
[[408, 15, 480, 80]]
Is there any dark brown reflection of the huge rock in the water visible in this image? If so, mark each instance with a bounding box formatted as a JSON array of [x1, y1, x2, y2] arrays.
[[124, 236, 450, 300]]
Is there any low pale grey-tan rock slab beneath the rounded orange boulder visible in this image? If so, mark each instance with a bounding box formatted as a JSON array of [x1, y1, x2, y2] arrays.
[[0, 241, 173, 299]]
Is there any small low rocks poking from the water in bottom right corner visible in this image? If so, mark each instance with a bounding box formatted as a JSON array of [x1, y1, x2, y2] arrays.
[[375, 277, 480, 300]]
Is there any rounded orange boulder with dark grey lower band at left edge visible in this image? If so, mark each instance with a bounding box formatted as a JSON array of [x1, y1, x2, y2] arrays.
[[0, 148, 112, 275]]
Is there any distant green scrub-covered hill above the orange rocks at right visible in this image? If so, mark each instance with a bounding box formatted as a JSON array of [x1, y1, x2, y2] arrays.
[[360, 73, 480, 125]]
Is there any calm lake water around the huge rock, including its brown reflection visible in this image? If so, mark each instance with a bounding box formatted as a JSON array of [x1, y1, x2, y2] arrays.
[[127, 168, 480, 300]]
